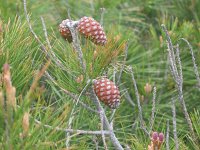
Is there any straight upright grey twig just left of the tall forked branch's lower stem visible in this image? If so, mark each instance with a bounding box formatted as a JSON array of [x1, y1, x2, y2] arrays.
[[172, 98, 179, 150]]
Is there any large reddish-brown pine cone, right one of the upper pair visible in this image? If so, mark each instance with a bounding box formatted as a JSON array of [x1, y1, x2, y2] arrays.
[[77, 17, 107, 45]]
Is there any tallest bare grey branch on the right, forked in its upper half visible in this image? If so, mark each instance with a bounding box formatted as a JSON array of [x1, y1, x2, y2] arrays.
[[161, 24, 195, 138]]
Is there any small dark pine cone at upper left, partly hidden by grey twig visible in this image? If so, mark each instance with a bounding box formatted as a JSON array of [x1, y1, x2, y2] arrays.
[[59, 19, 72, 43]]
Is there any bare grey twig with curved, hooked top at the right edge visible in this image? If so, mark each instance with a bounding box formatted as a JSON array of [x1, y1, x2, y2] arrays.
[[180, 38, 200, 89]]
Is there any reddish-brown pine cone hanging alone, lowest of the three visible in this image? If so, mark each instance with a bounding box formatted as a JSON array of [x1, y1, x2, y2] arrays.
[[94, 77, 120, 109]]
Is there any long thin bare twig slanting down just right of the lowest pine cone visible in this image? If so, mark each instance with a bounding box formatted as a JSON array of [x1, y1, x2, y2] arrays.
[[129, 67, 150, 137]]
